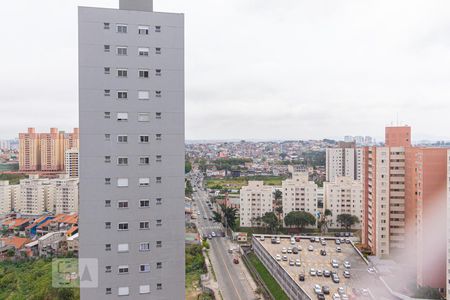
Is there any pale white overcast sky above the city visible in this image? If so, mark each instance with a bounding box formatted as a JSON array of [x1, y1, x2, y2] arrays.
[[0, 0, 450, 140]]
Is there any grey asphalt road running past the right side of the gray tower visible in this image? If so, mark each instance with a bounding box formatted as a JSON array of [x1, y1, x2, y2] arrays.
[[189, 175, 253, 300]]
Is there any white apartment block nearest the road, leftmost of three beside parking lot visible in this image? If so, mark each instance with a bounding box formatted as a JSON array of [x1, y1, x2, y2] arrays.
[[239, 181, 275, 227]]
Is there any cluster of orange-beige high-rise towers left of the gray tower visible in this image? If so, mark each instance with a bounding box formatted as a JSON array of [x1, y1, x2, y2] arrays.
[[19, 128, 79, 172]]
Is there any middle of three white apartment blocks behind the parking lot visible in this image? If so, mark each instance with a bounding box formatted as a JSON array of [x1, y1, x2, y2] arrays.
[[281, 172, 319, 216]]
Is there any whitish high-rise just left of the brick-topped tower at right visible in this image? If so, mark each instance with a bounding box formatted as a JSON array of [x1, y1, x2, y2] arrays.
[[326, 142, 364, 182]]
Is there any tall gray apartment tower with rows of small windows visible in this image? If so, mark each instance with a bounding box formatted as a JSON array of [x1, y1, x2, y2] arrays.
[[78, 0, 185, 300]]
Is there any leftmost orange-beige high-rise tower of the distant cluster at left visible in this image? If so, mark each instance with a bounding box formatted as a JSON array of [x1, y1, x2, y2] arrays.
[[19, 128, 41, 171]]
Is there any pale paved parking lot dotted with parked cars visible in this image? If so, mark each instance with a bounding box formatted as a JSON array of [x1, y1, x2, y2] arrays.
[[255, 236, 393, 300]]
